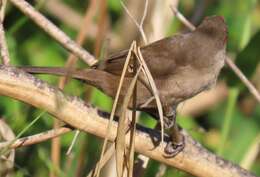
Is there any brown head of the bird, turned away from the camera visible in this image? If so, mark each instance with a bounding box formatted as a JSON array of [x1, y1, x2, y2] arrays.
[[196, 16, 228, 48]]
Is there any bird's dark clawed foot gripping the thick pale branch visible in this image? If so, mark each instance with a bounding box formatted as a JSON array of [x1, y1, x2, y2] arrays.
[[164, 136, 185, 158]]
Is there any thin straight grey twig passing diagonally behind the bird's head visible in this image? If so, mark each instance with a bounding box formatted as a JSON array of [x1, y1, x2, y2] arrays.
[[170, 6, 260, 103]]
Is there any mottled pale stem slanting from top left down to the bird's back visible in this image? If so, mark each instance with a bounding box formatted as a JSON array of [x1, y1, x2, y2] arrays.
[[10, 0, 97, 66]]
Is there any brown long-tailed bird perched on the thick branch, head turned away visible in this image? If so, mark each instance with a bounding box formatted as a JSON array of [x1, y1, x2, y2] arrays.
[[13, 16, 227, 156]]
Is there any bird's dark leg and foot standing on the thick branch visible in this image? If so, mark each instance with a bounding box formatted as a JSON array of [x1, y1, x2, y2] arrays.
[[164, 107, 185, 157]]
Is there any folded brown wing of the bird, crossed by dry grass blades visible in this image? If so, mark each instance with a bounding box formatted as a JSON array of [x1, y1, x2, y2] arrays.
[[98, 35, 185, 77]]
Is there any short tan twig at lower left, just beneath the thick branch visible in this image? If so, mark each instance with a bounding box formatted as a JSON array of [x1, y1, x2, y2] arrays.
[[0, 127, 73, 149]]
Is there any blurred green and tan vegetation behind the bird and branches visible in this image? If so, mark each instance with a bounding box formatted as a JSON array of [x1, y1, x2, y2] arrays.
[[0, 0, 260, 177]]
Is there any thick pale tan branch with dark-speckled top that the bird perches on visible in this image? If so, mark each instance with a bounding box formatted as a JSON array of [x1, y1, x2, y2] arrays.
[[0, 66, 254, 177]]
